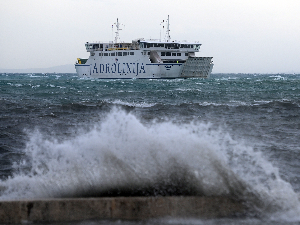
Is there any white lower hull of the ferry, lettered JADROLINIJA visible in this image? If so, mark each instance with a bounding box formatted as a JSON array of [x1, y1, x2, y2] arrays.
[[75, 51, 213, 79]]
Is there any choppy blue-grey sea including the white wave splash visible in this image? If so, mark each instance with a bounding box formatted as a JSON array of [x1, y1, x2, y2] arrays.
[[0, 73, 300, 225]]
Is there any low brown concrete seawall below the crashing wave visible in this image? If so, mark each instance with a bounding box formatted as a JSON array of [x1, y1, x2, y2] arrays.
[[0, 196, 246, 224]]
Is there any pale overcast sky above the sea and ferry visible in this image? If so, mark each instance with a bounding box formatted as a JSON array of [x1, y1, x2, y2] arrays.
[[0, 0, 300, 73]]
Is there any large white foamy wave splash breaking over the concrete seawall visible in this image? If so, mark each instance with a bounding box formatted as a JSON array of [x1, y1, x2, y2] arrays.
[[0, 109, 300, 218]]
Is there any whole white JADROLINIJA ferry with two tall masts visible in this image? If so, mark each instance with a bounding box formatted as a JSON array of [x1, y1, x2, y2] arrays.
[[75, 16, 213, 79]]
